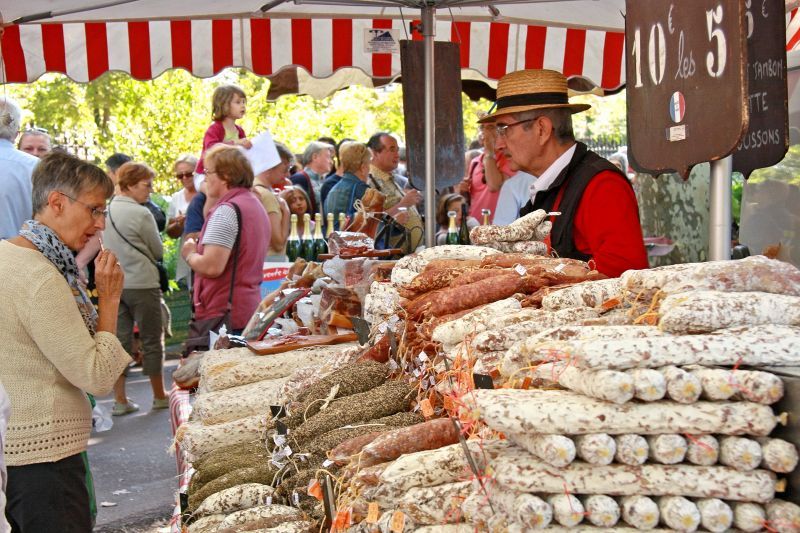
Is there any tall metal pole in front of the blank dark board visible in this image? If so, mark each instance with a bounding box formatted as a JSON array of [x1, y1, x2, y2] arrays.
[[422, 2, 436, 248]]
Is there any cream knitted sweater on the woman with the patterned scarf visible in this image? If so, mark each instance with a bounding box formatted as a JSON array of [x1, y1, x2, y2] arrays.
[[0, 241, 131, 466]]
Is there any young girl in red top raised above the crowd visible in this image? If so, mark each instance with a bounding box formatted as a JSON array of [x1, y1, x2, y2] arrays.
[[196, 85, 252, 174]]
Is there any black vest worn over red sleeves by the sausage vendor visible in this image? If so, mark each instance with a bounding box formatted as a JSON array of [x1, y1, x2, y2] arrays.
[[519, 142, 632, 261]]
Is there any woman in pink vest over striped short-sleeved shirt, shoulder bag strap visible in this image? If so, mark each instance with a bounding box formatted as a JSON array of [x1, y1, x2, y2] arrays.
[[181, 144, 271, 332]]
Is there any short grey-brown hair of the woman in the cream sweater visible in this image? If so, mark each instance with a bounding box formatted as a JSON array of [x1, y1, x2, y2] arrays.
[[31, 150, 114, 215]]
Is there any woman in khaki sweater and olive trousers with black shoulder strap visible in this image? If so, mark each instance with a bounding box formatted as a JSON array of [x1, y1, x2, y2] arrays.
[[103, 162, 169, 416]]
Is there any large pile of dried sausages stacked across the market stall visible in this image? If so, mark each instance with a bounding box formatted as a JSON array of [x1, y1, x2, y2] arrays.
[[170, 213, 800, 532]]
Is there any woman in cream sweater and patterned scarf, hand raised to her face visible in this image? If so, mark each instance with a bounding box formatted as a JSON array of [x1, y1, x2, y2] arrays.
[[0, 152, 131, 533]]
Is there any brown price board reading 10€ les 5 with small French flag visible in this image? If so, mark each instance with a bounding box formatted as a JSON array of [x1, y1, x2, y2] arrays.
[[625, 0, 749, 178]]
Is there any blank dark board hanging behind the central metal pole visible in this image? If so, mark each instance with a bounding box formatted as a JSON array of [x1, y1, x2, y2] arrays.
[[400, 41, 464, 191]]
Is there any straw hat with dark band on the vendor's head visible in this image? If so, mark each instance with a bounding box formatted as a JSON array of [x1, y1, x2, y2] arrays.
[[478, 69, 591, 123]]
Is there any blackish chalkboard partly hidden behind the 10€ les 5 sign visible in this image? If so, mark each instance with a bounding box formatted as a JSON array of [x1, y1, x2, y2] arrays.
[[733, 0, 789, 178]]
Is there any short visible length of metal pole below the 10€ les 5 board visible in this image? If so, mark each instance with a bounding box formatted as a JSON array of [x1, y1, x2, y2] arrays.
[[708, 156, 733, 261]]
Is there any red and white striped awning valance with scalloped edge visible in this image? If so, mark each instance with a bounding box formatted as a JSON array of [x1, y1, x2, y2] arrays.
[[0, 18, 625, 89]]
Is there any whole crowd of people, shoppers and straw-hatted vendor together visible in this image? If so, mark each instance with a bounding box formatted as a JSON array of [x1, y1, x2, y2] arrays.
[[0, 70, 647, 533]]
